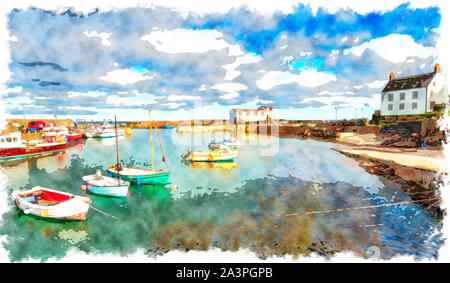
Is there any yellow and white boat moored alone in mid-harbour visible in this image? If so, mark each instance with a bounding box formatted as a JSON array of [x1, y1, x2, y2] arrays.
[[181, 145, 239, 162]]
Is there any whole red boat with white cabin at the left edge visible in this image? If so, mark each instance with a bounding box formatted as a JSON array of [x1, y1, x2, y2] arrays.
[[0, 133, 81, 161]]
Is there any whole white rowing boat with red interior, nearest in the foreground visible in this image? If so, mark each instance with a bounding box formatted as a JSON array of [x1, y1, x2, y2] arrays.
[[12, 186, 92, 221]]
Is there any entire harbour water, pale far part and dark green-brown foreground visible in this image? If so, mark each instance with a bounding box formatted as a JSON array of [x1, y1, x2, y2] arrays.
[[0, 130, 442, 261]]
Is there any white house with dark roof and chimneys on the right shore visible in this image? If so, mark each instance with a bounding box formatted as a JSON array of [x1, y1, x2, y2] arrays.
[[381, 64, 449, 116]]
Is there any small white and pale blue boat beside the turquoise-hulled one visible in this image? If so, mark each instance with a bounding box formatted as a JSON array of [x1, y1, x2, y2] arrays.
[[81, 170, 130, 198]]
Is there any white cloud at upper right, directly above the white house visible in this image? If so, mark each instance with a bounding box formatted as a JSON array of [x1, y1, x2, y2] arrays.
[[344, 34, 437, 63]]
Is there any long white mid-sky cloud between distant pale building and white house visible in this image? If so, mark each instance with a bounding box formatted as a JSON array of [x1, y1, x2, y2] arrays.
[[256, 68, 336, 90]]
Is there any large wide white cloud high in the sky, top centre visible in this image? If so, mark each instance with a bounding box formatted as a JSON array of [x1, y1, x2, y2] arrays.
[[141, 28, 244, 56]]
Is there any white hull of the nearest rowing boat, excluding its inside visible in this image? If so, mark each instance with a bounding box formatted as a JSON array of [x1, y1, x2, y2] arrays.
[[12, 187, 91, 221]]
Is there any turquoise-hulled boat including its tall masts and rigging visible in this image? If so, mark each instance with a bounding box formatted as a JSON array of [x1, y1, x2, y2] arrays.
[[107, 110, 170, 186]]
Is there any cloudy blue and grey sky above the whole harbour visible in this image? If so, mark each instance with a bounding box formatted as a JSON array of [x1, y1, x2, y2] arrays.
[[2, 1, 445, 121]]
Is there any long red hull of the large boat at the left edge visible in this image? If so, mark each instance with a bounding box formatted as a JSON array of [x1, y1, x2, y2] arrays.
[[0, 140, 81, 161]]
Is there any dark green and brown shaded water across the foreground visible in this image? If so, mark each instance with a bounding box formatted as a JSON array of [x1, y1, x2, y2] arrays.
[[0, 148, 442, 261]]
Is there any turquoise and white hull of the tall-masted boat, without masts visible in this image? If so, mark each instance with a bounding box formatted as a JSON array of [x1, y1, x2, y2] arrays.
[[107, 166, 170, 185]]
